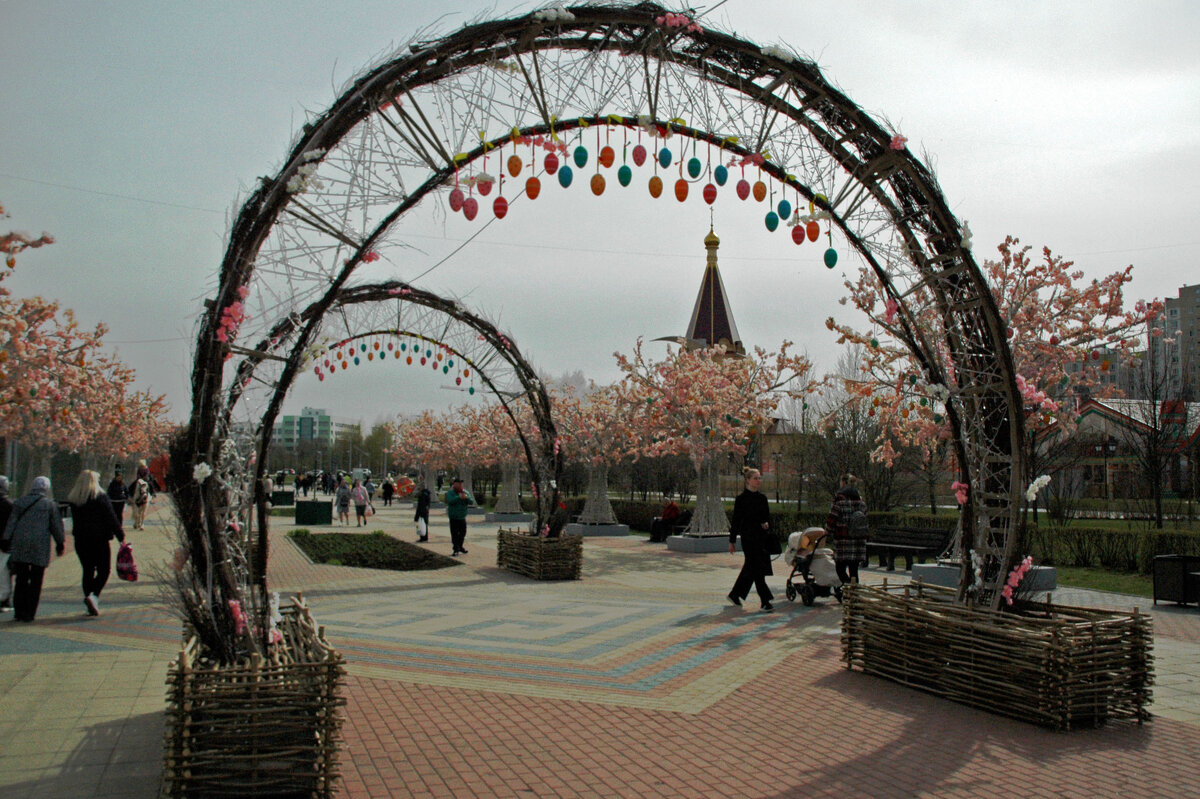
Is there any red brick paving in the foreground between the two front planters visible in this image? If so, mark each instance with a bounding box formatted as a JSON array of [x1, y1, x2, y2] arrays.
[[338, 636, 1200, 799]]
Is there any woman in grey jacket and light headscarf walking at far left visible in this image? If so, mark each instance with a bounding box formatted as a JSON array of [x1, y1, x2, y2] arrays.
[[0, 477, 66, 621]]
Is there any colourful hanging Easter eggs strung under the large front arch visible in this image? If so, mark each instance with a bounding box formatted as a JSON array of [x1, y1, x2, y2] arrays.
[[448, 115, 838, 269]]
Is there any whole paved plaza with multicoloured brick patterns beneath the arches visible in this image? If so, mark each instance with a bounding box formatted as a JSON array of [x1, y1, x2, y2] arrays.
[[0, 505, 1200, 799]]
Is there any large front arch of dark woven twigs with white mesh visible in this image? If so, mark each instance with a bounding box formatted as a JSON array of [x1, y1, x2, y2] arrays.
[[175, 4, 1025, 623]]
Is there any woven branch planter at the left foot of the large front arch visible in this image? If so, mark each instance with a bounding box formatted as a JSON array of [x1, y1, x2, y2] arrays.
[[163, 605, 346, 799]]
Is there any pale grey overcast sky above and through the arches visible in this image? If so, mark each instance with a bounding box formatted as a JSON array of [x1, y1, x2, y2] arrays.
[[0, 0, 1200, 423]]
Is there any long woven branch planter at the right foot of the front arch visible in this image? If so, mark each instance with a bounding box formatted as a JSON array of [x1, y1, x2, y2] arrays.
[[841, 584, 1154, 731]]
